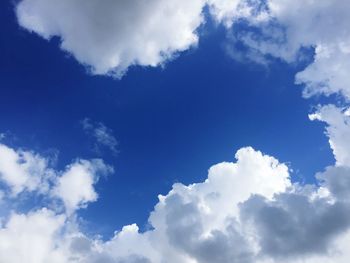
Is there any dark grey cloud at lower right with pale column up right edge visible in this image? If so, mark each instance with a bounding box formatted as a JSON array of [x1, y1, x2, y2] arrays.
[[240, 105, 350, 262]]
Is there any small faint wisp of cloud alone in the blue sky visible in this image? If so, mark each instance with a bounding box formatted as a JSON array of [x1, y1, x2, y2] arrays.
[[81, 118, 118, 154]]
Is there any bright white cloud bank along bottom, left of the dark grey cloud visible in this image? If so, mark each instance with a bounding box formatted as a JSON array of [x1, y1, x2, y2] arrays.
[[0, 143, 291, 263]]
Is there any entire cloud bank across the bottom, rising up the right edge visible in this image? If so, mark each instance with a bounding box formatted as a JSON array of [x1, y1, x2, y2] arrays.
[[0, 106, 350, 263]]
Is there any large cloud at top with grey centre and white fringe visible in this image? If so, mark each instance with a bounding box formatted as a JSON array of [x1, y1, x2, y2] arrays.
[[16, 0, 249, 77]]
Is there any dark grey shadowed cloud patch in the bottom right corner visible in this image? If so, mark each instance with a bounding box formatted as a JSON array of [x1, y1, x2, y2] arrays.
[[241, 190, 350, 262]]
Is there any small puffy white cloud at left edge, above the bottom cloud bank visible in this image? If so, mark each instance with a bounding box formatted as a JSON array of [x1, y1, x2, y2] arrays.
[[0, 144, 113, 211]]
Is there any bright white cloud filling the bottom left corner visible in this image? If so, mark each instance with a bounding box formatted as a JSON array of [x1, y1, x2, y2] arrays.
[[0, 209, 68, 263]]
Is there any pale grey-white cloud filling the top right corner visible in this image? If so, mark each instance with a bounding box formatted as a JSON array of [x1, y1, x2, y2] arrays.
[[269, 0, 350, 99]]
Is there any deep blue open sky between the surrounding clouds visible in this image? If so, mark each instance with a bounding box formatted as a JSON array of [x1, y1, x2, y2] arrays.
[[0, 0, 347, 263]]
